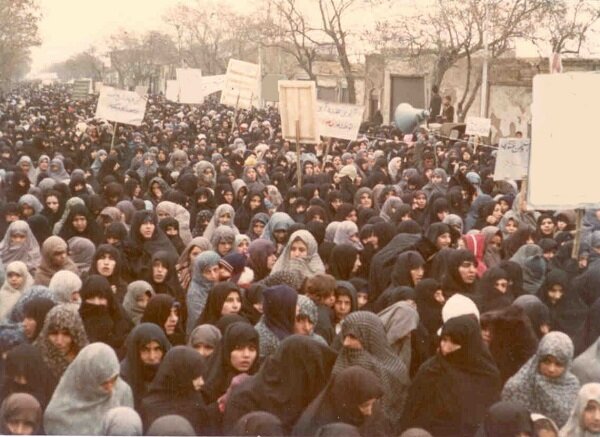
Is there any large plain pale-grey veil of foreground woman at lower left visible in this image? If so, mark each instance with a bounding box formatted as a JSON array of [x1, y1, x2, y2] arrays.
[[44, 343, 133, 435]]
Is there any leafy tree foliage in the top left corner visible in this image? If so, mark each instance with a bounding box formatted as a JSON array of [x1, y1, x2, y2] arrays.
[[0, 0, 41, 83]]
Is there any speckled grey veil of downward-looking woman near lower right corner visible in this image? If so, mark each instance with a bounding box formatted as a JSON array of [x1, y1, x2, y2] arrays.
[[502, 332, 580, 426]]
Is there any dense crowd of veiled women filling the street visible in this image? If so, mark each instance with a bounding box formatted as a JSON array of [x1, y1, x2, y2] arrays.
[[0, 84, 600, 437]]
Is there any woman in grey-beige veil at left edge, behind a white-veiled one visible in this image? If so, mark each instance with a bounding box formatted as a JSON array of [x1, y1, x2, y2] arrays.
[[0, 220, 41, 273]]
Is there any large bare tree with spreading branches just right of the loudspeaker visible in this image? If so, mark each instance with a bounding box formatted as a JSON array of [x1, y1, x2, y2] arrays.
[[367, 0, 556, 120]]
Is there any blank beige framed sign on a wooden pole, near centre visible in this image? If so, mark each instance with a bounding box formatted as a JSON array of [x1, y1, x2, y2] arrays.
[[278, 80, 320, 144]]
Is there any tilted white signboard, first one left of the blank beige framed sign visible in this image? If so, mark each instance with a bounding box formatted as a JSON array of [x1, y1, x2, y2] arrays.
[[221, 59, 260, 109]]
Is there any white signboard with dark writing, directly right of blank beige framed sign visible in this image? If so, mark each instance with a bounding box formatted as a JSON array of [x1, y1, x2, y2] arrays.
[[317, 100, 365, 141]]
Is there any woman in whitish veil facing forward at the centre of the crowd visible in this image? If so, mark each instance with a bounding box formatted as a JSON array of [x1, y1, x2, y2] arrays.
[[271, 230, 325, 276]]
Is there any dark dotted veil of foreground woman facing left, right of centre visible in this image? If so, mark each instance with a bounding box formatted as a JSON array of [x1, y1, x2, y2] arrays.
[[333, 311, 409, 424]]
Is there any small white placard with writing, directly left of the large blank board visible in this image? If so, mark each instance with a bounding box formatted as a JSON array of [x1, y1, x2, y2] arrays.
[[494, 138, 531, 181]]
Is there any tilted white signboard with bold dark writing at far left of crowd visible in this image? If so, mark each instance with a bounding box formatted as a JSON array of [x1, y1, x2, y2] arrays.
[[96, 86, 146, 126]]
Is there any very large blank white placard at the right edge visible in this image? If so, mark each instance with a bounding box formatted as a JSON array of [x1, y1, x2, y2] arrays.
[[527, 73, 600, 209]]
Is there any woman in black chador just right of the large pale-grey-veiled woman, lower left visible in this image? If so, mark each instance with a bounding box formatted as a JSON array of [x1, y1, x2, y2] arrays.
[[121, 323, 171, 408]]
